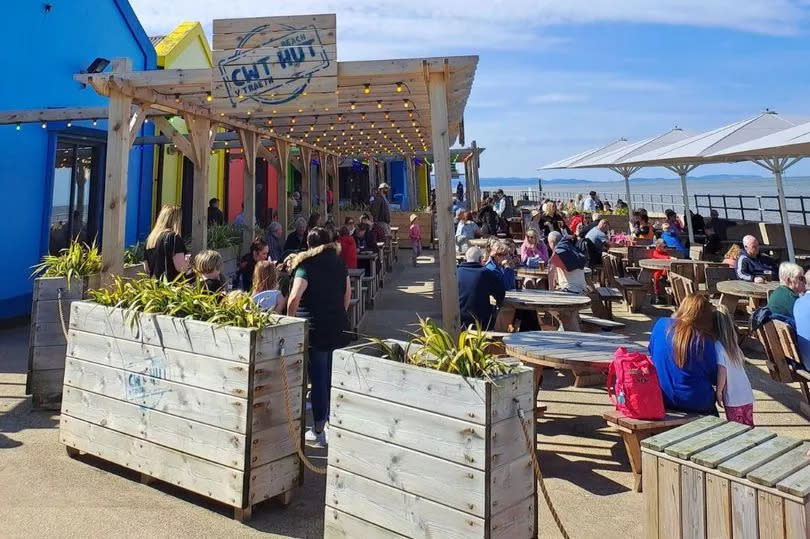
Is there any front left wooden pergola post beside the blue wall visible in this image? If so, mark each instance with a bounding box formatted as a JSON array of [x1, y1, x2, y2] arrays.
[[101, 58, 132, 281]]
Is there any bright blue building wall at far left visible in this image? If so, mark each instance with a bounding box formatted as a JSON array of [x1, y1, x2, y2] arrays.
[[0, 0, 156, 319]]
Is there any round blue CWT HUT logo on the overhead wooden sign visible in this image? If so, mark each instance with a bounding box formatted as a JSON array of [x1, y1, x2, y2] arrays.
[[218, 24, 330, 107]]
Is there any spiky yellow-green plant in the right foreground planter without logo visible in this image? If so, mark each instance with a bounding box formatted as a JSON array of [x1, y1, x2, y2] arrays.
[[371, 317, 515, 379]]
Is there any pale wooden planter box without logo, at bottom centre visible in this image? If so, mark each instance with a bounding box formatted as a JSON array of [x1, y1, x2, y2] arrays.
[[324, 345, 537, 539]]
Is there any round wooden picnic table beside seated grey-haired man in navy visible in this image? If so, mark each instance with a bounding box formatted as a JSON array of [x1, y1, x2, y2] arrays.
[[498, 290, 591, 331]]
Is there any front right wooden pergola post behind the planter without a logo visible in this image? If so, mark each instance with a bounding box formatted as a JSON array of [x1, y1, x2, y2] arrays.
[[428, 72, 461, 334]]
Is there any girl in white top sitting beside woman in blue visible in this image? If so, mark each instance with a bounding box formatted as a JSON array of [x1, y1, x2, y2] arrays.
[[714, 305, 754, 427]]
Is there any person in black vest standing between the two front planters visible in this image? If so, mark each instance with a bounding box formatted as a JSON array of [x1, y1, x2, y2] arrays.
[[287, 227, 351, 446]]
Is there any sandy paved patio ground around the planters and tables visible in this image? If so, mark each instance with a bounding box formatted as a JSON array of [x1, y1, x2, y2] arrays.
[[0, 253, 810, 539]]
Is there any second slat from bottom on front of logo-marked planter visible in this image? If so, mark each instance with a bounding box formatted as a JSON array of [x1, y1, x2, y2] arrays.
[[62, 387, 245, 470]]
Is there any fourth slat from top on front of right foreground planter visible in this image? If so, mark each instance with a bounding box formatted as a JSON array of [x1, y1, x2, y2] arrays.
[[326, 469, 485, 539]]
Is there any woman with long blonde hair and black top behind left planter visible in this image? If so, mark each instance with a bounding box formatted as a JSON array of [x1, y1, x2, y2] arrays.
[[144, 205, 189, 281]]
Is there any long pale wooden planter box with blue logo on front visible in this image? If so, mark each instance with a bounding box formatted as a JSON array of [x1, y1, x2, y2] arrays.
[[59, 302, 306, 519]]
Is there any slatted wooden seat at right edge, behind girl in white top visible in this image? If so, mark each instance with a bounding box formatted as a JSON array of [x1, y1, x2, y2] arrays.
[[756, 320, 810, 418]]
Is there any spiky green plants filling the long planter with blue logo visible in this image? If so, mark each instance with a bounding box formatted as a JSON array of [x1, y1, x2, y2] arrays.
[[89, 275, 280, 328]]
